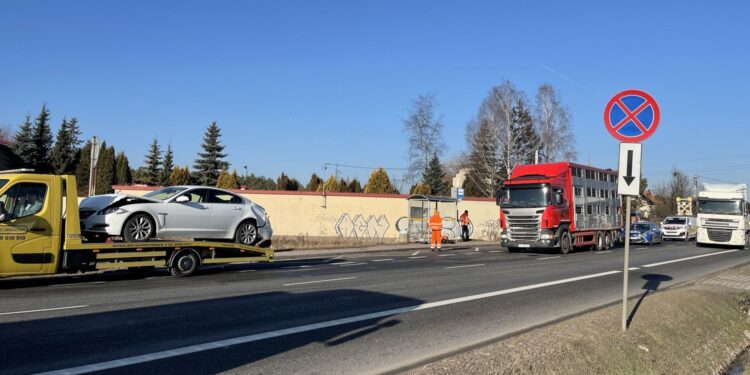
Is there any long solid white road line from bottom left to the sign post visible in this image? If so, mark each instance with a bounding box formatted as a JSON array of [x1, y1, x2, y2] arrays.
[[39, 271, 621, 375]]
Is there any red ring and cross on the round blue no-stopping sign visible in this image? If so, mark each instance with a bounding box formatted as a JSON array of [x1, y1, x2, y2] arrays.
[[604, 90, 660, 143]]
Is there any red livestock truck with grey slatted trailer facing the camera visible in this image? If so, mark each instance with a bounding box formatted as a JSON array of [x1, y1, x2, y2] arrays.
[[497, 163, 622, 254]]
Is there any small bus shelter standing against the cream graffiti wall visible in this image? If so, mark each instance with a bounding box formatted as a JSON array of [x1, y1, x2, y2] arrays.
[[406, 194, 461, 243]]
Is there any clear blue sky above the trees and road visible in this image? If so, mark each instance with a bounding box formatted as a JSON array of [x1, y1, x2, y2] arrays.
[[0, 0, 750, 189]]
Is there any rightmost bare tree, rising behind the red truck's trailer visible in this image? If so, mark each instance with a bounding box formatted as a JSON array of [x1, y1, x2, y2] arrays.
[[534, 84, 576, 162]]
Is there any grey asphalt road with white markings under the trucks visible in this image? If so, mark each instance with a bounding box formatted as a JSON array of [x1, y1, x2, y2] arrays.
[[0, 242, 750, 374]]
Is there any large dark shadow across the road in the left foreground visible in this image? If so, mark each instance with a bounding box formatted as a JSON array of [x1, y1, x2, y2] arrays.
[[0, 289, 423, 374]]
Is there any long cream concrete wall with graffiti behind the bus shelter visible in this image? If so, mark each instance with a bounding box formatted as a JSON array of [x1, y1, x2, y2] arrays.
[[113, 186, 499, 242]]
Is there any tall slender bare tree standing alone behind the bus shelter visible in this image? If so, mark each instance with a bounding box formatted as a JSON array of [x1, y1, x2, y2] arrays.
[[404, 94, 445, 181]]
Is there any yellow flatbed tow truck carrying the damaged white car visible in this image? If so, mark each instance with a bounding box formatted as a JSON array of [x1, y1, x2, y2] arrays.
[[0, 171, 274, 278]]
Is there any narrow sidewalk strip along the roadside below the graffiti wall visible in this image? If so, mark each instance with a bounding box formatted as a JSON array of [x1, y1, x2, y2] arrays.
[[275, 240, 500, 259]]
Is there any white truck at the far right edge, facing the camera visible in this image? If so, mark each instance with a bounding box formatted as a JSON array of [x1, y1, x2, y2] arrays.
[[696, 184, 750, 247]]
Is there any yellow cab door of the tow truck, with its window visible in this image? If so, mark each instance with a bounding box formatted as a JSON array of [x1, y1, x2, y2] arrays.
[[0, 178, 55, 276]]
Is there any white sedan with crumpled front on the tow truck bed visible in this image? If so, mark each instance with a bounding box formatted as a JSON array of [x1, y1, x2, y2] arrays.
[[79, 186, 273, 247]]
